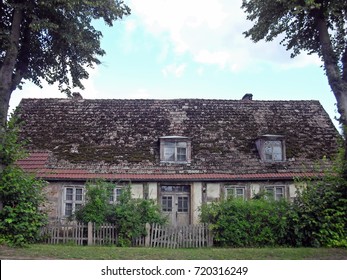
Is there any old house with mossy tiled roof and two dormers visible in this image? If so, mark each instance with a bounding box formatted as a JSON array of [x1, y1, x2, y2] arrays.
[[18, 95, 339, 225]]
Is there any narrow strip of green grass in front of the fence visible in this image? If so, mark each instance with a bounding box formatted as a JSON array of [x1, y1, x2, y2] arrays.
[[0, 244, 347, 260]]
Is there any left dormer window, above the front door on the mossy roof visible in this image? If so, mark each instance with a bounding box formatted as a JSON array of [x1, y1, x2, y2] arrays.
[[160, 136, 190, 163]]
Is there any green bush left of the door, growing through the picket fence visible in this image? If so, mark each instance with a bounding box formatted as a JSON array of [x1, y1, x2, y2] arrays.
[[76, 181, 166, 246]]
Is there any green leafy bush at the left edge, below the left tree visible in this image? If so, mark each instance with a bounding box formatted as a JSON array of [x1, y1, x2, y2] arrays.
[[0, 115, 46, 246]]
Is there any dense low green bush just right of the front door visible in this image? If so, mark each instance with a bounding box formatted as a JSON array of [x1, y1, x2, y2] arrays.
[[201, 198, 289, 247]]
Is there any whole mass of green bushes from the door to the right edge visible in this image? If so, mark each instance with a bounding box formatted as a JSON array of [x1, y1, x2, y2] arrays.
[[201, 151, 347, 247]]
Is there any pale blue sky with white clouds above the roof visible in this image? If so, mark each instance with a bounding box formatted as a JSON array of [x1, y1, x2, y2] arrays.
[[10, 0, 338, 129]]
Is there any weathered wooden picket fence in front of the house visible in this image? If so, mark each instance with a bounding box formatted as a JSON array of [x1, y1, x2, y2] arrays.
[[41, 221, 213, 248]]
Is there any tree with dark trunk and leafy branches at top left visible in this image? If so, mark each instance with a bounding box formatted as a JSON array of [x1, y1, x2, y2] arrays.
[[0, 0, 130, 173]]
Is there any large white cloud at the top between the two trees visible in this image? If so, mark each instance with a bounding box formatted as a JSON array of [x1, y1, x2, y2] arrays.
[[129, 0, 319, 71]]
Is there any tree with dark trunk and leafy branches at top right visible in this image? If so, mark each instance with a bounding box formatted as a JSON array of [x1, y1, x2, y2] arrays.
[[242, 0, 347, 168]]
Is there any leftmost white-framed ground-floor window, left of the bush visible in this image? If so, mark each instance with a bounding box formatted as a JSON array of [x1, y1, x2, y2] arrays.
[[63, 186, 83, 216]]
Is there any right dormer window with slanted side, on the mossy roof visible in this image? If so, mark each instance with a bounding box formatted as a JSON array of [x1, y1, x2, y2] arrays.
[[256, 134, 285, 162]]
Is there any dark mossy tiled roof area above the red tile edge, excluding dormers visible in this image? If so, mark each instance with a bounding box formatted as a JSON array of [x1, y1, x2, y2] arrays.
[[18, 99, 339, 174]]
